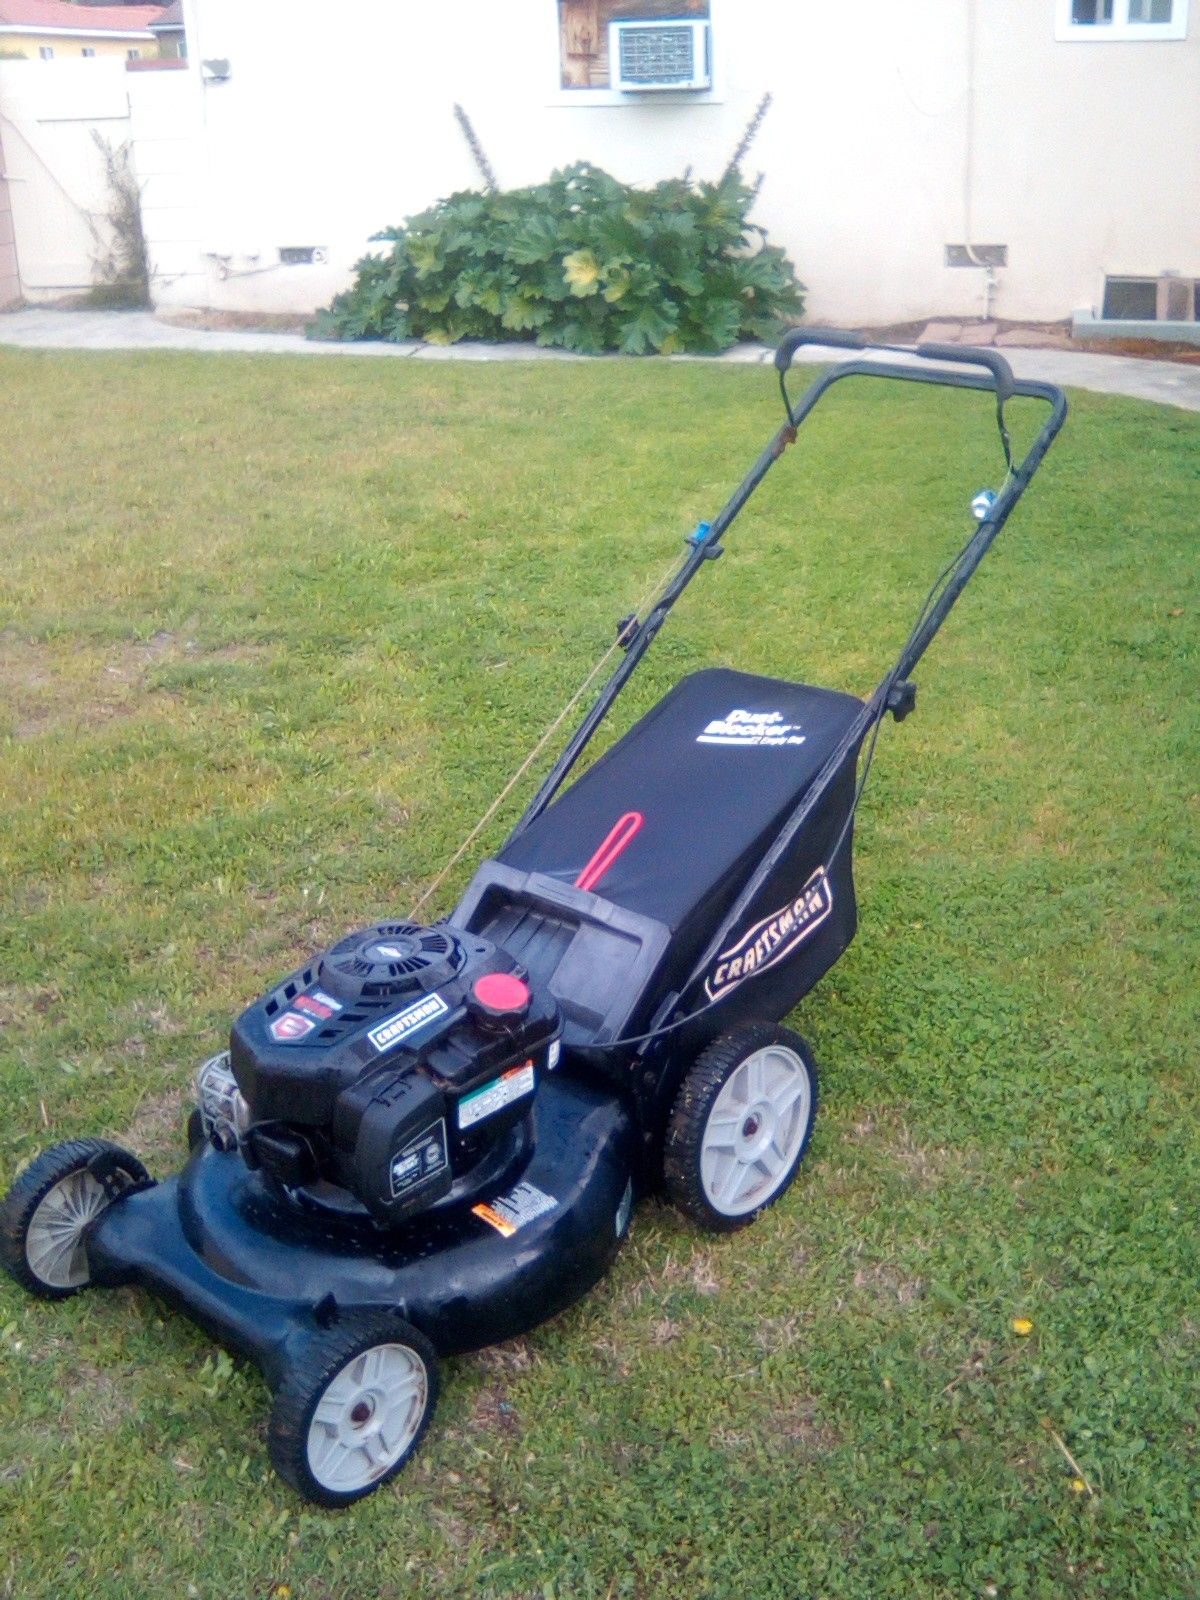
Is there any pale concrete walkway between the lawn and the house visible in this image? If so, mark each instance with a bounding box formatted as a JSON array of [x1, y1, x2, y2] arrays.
[[0, 309, 1200, 411]]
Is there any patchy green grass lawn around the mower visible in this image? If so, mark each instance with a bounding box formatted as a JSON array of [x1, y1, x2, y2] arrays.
[[0, 352, 1200, 1600]]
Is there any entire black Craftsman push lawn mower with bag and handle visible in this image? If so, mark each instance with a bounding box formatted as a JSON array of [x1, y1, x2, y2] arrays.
[[0, 328, 1066, 1506]]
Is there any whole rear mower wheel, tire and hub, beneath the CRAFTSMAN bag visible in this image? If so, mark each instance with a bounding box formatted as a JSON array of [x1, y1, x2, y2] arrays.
[[662, 1022, 818, 1234]]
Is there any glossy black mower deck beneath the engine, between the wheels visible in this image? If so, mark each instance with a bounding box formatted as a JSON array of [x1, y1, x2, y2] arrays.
[[86, 1077, 634, 1386]]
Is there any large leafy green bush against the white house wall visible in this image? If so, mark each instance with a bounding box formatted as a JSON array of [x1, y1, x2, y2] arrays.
[[312, 163, 805, 355]]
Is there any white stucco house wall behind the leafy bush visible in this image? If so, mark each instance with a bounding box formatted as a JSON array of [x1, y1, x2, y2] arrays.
[[0, 0, 1200, 323]]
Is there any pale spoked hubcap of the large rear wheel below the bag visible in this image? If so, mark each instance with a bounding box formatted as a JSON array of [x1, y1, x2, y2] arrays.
[[701, 1045, 813, 1216]]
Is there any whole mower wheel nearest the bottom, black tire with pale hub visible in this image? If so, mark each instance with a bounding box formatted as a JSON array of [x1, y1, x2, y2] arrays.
[[267, 1312, 442, 1507]]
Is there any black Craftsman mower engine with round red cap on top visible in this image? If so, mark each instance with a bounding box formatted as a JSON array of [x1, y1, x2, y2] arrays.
[[197, 923, 562, 1227]]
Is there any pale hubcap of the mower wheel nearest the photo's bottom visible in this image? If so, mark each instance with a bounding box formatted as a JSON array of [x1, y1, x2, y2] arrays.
[[307, 1344, 429, 1493]]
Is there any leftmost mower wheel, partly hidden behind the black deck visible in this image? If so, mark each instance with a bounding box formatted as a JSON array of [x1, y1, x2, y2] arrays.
[[0, 1139, 150, 1299]]
